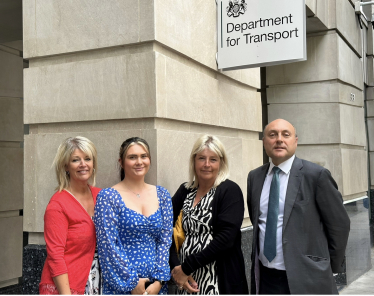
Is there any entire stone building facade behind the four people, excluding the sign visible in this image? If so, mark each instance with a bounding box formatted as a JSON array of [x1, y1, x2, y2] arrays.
[[0, 0, 374, 294]]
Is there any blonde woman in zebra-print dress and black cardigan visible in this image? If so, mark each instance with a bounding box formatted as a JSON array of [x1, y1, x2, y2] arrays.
[[170, 135, 248, 295]]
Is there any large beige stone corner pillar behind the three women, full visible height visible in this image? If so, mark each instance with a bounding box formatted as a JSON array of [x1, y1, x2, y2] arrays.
[[23, 0, 262, 235]]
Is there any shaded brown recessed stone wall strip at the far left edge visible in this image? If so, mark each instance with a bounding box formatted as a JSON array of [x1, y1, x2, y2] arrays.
[[0, 44, 24, 287]]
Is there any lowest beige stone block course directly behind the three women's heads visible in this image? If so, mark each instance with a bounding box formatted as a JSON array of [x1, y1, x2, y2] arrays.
[[24, 118, 262, 232]]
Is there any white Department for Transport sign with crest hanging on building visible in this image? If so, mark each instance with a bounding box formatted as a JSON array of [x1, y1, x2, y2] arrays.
[[216, 0, 306, 70]]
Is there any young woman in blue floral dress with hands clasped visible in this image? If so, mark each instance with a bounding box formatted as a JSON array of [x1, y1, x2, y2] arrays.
[[94, 137, 173, 295]]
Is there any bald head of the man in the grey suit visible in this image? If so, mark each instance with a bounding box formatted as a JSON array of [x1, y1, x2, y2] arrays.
[[262, 119, 297, 166]]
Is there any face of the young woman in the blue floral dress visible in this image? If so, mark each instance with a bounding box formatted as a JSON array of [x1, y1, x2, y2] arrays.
[[120, 144, 151, 177]]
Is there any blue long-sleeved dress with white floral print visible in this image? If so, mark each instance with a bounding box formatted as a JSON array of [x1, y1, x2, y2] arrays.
[[94, 186, 173, 294]]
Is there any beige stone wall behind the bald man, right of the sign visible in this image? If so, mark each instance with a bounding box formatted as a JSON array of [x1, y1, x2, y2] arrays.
[[266, 0, 368, 200]]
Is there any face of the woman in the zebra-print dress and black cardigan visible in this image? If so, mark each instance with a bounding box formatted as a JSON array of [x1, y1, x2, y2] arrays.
[[195, 148, 221, 185]]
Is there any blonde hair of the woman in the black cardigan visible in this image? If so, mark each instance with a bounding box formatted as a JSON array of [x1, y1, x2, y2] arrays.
[[186, 135, 229, 188]]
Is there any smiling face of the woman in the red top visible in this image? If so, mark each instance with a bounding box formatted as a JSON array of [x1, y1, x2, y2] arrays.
[[65, 149, 93, 182]]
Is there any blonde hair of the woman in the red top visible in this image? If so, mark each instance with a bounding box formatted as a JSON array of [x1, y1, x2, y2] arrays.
[[52, 136, 97, 192]]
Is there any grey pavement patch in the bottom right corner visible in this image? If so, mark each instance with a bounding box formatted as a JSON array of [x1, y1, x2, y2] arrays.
[[339, 248, 374, 295]]
